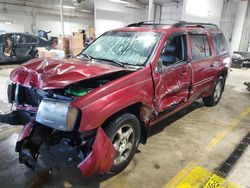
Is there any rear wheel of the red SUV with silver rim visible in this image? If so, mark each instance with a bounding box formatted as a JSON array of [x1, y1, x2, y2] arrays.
[[202, 76, 225, 107]]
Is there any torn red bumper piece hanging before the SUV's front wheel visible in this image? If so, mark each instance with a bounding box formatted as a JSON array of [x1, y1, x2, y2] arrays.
[[78, 127, 116, 176]]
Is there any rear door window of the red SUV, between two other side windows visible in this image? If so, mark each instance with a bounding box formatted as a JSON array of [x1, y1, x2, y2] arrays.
[[190, 34, 211, 60]]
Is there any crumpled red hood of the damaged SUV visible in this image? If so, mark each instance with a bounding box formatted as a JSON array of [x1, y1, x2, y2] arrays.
[[10, 58, 124, 89]]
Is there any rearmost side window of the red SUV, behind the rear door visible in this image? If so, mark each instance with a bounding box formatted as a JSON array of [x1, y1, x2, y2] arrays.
[[211, 33, 227, 55]]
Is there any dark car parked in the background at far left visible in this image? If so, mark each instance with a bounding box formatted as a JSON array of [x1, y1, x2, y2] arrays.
[[0, 33, 57, 64]]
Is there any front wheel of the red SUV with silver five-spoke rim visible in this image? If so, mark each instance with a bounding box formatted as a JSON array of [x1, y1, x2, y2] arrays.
[[104, 113, 141, 173]]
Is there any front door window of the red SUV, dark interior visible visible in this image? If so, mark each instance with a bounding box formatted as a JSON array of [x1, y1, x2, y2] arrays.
[[161, 35, 187, 66]]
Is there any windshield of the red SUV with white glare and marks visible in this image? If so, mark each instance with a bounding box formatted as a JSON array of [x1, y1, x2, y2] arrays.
[[81, 31, 161, 66]]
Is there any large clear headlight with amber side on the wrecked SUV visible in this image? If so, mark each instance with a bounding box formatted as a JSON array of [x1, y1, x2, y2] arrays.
[[36, 99, 79, 132]]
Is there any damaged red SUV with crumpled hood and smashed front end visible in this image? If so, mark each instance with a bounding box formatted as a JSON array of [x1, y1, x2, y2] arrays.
[[1, 22, 230, 176]]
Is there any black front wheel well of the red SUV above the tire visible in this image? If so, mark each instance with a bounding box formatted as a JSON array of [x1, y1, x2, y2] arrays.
[[102, 103, 148, 144]]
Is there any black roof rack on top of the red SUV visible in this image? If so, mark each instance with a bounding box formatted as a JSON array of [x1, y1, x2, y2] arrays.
[[127, 21, 219, 29]]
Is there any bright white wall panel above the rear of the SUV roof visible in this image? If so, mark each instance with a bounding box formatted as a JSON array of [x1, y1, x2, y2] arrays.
[[182, 0, 223, 25]]
